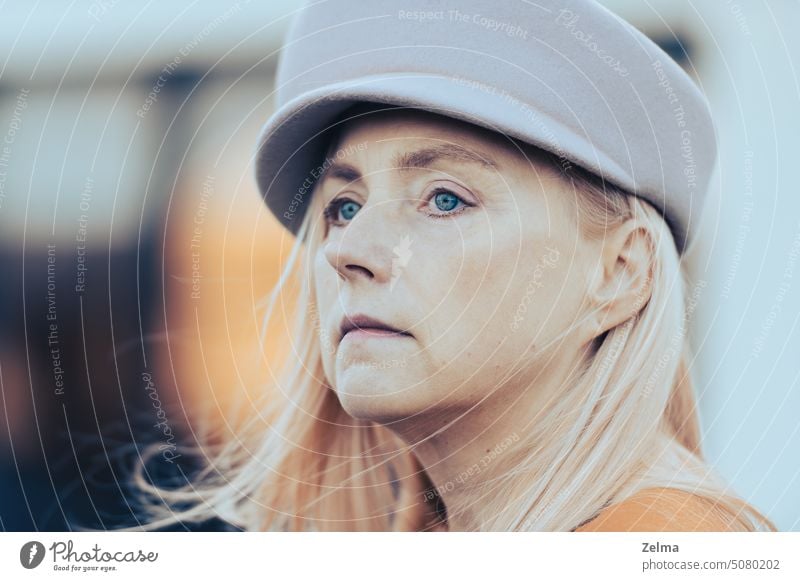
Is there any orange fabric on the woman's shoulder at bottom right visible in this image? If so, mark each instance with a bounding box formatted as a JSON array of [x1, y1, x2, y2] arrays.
[[575, 488, 733, 532]]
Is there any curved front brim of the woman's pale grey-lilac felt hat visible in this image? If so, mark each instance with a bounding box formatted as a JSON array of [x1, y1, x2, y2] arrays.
[[256, 73, 644, 241]]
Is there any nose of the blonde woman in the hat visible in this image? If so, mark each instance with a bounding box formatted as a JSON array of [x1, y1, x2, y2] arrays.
[[324, 204, 398, 283]]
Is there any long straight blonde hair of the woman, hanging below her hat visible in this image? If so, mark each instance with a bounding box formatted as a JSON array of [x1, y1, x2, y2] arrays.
[[123, 125, 776, 531]]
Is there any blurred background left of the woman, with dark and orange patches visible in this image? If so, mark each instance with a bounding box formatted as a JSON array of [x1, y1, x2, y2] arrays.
[[0, 2, 291, 531]]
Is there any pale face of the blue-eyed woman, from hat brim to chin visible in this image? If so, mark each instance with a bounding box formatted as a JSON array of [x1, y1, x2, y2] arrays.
[[312, 110, 590, 422]]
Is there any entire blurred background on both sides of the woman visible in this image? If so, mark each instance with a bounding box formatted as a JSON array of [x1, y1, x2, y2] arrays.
[[0, 0, 800, 531]]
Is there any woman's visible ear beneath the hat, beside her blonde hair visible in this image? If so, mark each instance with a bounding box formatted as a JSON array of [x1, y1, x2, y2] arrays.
[[587, 218, 654, 340]]
